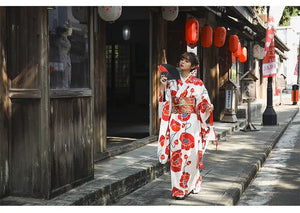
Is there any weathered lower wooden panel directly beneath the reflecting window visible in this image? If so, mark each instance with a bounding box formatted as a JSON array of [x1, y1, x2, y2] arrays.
[[50, 98, 93, 194]]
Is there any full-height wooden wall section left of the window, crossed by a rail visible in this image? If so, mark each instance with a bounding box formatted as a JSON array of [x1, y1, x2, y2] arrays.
[[6, 7, 50, 198]]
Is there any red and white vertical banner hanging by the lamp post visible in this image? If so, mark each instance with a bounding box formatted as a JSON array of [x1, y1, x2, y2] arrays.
[[263, 16, 276, 78]]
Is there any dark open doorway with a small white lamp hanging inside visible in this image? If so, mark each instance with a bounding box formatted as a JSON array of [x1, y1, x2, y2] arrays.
[[106, 7, 149, 149]]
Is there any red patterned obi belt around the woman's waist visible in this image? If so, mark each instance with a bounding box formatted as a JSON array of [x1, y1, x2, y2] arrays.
[[171, 97, 196, 114]]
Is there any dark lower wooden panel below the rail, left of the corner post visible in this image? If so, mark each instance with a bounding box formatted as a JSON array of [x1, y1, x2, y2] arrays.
[[10, 99, 42, 197]]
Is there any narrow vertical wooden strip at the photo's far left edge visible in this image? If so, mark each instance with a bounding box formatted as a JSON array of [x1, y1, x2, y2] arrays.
[[0, 7, 9, 198]]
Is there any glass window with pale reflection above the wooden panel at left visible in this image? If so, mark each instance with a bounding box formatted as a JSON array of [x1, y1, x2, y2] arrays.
[[49, 7, 89, 89]]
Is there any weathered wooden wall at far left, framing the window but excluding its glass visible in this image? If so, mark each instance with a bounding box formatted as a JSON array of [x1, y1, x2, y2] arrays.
[[0, 7, 94, 198]]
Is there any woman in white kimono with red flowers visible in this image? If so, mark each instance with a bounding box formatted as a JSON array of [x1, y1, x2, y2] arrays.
[[157, 52, 213, 199]]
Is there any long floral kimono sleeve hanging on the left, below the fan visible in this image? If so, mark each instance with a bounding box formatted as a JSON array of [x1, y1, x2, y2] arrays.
[[157, 82, 171, 164]]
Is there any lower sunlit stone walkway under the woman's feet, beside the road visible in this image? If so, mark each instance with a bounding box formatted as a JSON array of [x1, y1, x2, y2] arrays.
[[115, 102, 299, 205]]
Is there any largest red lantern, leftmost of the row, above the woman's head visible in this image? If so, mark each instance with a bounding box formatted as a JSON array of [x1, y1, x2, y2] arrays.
[[185, 18, 199, 46]]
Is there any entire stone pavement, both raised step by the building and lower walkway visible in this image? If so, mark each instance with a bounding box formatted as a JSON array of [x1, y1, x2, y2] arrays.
[[0, 94, 299, 205]]
